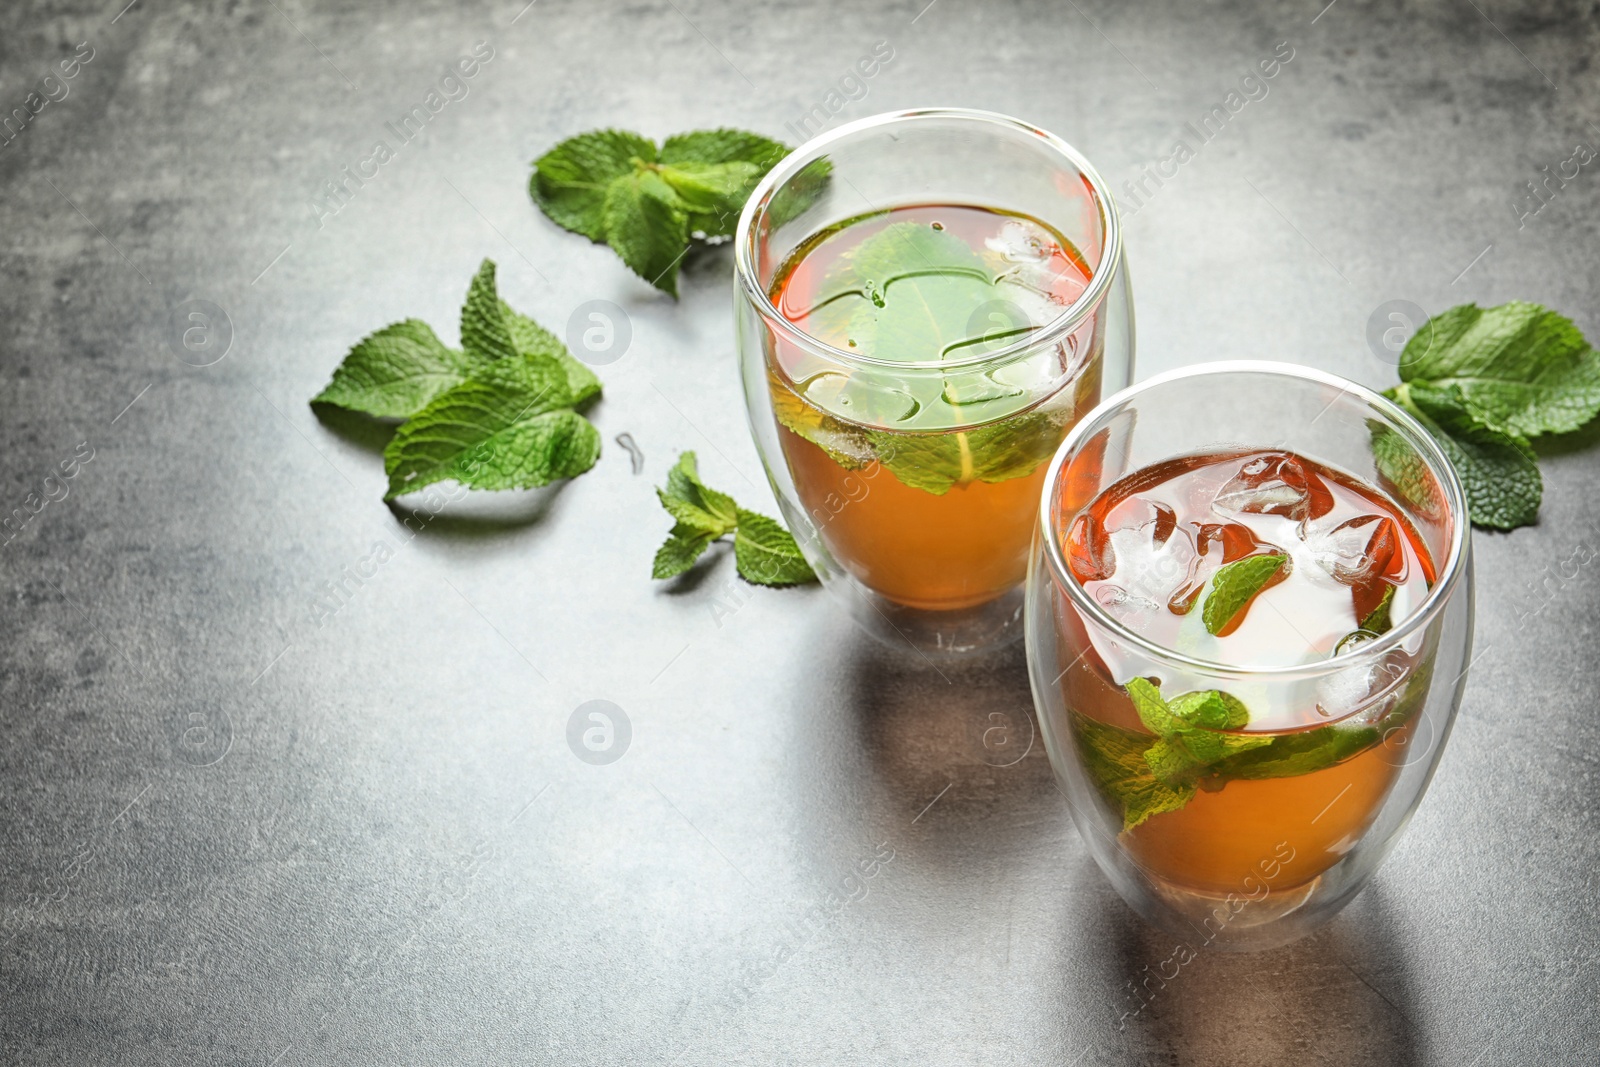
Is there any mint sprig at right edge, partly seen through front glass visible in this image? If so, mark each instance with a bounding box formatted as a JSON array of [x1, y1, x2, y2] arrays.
[[1373, 301, 1600, 530]]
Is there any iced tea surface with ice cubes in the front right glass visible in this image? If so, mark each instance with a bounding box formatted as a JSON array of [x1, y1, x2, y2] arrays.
[[1064, 451, 1434, 667]]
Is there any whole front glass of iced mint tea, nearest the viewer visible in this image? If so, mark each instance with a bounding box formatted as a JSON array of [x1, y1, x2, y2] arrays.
[[1027, 363, 1472, 949]]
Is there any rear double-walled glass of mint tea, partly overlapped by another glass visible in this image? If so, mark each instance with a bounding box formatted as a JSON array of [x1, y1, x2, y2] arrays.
[[734, 110, 1133, 653]]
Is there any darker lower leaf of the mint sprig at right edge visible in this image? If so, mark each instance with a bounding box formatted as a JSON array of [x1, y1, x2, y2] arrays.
[[1379, 382, 1544, 530]]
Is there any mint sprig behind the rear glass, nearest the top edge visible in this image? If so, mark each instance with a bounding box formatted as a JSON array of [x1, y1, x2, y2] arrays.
[[528, 130, 789, 298]]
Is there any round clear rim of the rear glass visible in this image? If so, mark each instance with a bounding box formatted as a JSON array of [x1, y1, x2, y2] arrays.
[[733, 107, 1122, 370]]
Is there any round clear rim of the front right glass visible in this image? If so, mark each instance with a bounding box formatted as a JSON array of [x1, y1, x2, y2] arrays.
[[1037, 360, 1472, 678]]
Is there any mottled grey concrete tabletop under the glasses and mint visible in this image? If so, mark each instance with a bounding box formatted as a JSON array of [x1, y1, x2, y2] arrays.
[[0, 0, 1600, 1067]]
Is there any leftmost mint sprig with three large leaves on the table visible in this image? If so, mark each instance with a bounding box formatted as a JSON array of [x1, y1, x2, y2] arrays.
[[312, 259, 600, 499]]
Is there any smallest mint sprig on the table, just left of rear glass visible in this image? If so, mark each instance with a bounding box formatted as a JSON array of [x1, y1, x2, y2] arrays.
[[651, 453, 816, 585]]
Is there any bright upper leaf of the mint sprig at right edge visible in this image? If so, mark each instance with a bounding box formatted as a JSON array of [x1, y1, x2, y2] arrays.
[[1400, 301, 1600, 437]]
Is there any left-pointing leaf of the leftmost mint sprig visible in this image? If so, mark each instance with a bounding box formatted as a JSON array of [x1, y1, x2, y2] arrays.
[[312, 318, 485, 419]]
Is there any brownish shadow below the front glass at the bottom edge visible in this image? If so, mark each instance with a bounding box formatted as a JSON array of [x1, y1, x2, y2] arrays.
[[1059, 880, 1421, 1067]]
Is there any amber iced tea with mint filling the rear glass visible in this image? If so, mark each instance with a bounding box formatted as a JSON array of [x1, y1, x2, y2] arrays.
[[770, 205, 1099, 611]]
